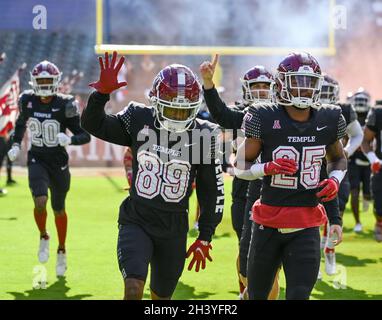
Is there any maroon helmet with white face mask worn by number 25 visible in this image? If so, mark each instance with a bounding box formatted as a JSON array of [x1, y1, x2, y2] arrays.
[[274, 52, 323, 109]]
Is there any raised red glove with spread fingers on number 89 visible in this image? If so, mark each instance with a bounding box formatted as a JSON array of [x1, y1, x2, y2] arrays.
[[89, 51, 127, 93]]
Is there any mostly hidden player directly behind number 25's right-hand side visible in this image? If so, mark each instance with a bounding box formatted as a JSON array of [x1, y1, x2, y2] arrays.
[[320, 74, 363, 275]]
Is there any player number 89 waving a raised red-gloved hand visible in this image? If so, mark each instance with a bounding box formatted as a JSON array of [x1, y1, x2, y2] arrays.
[[81, 52, 224, 299]]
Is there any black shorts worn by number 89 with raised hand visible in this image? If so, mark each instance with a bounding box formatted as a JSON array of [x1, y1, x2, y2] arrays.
[[117, 223, 187, 298]]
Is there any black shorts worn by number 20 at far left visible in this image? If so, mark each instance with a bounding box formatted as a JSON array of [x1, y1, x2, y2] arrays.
[[28, 152, 70, 211]]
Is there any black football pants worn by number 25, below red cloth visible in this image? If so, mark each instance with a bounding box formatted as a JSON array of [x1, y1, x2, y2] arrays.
[[247, 223, 320, 300]]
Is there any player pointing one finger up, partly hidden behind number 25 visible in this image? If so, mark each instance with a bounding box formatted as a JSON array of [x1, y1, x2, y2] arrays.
[[200, 55, 279, 300]]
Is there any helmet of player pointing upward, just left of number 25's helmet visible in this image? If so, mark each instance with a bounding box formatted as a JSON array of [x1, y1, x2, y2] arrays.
[[240, 66, 274, 103]]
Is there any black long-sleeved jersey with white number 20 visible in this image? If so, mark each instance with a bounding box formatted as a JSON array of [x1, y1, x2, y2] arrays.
[[13, 90, 90, 155]]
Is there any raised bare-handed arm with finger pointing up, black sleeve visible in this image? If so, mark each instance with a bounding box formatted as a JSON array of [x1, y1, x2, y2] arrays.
[[200, 54, 244, 129]]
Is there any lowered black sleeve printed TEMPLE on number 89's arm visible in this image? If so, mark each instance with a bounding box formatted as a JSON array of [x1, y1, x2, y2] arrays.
[[196, 159, 224, 242]]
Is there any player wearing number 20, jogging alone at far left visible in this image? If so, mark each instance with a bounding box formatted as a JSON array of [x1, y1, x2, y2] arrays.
[[8, 60, 90, 276]]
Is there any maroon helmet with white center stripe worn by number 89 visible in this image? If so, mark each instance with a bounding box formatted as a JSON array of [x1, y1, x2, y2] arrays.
[[149, 64, 203, 132]]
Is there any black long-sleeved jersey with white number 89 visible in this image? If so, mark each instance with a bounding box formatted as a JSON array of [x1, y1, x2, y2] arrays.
[[81, 92, 224, 241]]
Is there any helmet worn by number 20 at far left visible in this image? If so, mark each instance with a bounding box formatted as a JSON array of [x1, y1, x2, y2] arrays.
[[29, 60, 62, 97]]
